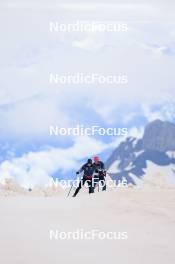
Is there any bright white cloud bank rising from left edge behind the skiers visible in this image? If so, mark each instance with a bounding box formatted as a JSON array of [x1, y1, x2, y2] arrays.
[[0, 137, 116, 188]]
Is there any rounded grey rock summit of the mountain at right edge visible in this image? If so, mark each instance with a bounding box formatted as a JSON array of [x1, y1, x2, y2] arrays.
[[143, 120, 175, 152]]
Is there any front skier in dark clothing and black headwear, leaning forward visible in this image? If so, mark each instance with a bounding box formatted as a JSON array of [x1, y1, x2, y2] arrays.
[[73, 159, 95, 197]]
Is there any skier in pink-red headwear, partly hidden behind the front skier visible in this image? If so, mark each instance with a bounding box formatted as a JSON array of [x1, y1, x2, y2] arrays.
[[93, 156, 106, 191]]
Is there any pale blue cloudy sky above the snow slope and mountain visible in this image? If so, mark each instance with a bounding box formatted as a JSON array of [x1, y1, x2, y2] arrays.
[[0, 0, 175, 188]]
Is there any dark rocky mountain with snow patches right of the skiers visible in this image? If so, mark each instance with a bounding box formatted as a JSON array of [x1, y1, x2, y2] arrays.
[[106, 120, 175, 184]]
